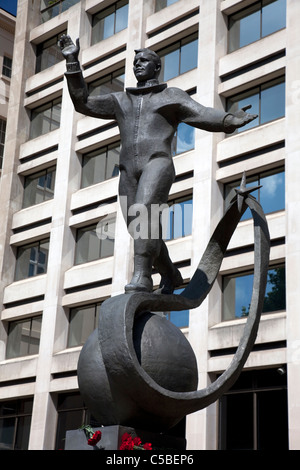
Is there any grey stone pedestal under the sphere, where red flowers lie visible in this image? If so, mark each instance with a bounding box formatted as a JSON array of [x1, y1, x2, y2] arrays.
[[65, 425, 186, 451]]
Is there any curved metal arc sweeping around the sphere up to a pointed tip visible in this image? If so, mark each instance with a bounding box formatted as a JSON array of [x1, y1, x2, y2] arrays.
[[99, 196, 270, 416]]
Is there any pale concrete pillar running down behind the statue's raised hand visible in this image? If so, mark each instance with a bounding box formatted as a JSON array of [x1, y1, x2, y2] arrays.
[[29, 3, 86, 450]]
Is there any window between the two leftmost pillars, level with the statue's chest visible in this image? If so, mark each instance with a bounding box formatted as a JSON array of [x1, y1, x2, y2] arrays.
[[29, 98, 61, 139]]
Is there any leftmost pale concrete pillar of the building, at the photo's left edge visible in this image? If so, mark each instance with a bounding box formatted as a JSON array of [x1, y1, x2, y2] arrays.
[[0, 0, 38, 360]]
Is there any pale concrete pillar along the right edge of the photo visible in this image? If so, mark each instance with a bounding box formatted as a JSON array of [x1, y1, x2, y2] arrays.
[[284, 0, 300, 450]]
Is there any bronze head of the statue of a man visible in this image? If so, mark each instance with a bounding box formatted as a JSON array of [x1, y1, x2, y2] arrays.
[[133, 49, 161, 82]]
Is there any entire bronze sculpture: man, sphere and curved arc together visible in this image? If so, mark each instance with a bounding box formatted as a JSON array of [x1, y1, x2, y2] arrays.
[[59, 35, 270, 433]]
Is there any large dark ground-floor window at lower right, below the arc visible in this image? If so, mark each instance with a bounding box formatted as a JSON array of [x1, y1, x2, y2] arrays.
[[219, 368, 288, 450]]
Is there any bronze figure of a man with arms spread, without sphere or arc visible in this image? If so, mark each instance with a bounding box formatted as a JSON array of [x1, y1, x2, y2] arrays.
[[59, 35, 257, 293]]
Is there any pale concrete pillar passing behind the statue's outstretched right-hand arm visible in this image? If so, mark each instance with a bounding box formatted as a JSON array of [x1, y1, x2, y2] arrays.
[[187, 0, 226, 450]]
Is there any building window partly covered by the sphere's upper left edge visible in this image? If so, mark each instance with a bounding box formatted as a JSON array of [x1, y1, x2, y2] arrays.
[[68, 303, 101, 348]]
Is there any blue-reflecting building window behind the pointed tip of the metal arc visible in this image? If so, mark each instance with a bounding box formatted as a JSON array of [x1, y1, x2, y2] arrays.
[[224, 167, 285, 220]]
